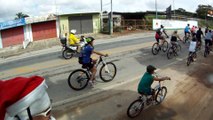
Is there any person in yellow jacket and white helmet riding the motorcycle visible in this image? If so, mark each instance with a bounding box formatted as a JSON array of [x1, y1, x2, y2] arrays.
[[69, 29, 81, 53]]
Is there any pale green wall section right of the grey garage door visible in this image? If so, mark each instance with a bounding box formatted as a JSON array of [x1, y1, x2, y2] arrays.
[[93, 15, 101, 33]]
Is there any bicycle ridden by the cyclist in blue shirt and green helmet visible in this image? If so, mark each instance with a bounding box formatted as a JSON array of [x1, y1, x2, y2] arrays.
[[68, 56, 117, 90]]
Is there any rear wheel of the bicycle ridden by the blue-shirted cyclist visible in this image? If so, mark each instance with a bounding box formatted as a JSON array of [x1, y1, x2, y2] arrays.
[[68, 69, 89, 90]]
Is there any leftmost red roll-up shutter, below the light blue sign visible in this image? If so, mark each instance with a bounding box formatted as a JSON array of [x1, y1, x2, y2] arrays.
[[1, 26, 24, 47]]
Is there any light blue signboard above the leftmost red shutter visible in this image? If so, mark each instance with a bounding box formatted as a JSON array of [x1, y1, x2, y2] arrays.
[[0, 18, 26, 30]]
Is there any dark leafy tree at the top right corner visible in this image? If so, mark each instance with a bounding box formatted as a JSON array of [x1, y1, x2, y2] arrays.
[[196, 5, 213, 19]]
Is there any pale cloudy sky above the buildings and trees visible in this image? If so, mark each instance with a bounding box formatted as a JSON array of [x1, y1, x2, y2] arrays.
[[0, 0, 213, 22]]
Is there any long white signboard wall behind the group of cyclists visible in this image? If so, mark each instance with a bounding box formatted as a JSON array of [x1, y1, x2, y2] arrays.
[[152, 19, 198, 30]]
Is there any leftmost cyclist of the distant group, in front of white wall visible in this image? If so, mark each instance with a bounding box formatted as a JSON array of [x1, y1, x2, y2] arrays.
[[155, 25, 169, 44]]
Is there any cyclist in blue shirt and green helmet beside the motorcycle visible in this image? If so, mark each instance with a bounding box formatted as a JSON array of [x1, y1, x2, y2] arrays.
[[82, 37, 108, 87]]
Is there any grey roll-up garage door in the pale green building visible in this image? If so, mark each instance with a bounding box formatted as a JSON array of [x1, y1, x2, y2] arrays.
[[69, 16, 93, 34]]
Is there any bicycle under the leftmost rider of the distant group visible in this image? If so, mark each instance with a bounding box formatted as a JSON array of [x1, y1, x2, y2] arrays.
[[152, 40, 168, 55]]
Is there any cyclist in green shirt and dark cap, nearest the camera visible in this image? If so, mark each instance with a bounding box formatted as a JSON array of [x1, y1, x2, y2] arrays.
[[138, 65, 170, 101]]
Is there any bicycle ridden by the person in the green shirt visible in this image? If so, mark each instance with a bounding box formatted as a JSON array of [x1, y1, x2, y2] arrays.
[[127, 81, 167, 118]]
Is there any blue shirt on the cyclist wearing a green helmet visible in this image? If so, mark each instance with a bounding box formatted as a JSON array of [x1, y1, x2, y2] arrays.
[[82, 45, 94, 64]]
